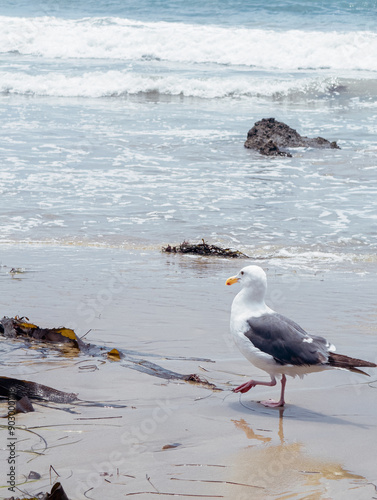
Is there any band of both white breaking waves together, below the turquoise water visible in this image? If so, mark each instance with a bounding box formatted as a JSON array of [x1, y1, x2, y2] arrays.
[[0, 16, 377, 99]]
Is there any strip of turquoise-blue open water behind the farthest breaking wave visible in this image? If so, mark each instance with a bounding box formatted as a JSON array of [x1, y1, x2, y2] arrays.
[[1, 0, 377, 30]]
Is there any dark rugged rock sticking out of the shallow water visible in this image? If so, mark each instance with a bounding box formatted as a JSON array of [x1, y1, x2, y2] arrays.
[[245, 118, 340, 156]]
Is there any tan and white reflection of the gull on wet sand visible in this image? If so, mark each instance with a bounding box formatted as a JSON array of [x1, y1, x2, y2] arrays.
[[232, 408, 370, 499]]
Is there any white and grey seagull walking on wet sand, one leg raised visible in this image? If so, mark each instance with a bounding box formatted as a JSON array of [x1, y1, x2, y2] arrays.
[[226, 265, 377, 408]]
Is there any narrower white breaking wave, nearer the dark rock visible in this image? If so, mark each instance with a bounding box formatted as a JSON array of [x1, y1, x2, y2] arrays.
[[0, 70, 364, 99]]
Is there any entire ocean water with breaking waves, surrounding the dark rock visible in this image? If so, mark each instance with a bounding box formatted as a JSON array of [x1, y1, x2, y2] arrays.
[[0, 0, 377, 271]]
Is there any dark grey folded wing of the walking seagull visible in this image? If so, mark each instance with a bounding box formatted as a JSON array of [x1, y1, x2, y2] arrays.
[[244, 313, 329, 365]]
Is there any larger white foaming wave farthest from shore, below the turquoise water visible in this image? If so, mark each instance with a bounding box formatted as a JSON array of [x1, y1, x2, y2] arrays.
[[0, 16, 377, 71]]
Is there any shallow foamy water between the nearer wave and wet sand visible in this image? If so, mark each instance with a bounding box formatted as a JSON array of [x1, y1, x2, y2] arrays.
[[1, 92, 377, 270]]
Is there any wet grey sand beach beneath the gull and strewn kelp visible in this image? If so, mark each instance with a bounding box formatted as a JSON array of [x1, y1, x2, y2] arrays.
[[0, 246, 377, 500]]
